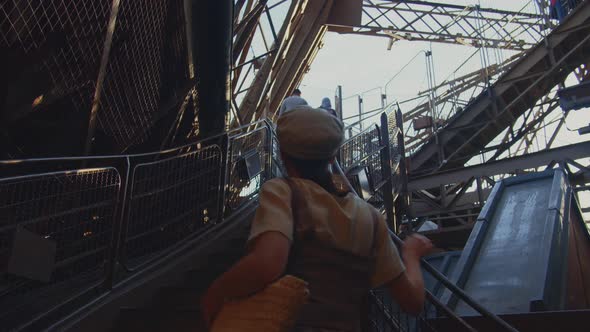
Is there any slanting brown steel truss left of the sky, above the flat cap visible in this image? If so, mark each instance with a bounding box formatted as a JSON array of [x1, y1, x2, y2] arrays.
[[232, 0, 334, 124]]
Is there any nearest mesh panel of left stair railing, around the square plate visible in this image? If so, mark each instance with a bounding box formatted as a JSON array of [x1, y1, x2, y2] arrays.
[[0, 168, 121, 322]]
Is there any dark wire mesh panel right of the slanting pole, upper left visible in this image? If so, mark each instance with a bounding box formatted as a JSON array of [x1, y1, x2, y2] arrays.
[[98, 0, 188, 150]]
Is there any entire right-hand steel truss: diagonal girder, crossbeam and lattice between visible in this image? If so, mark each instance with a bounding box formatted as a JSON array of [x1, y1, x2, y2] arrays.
[[409, 3, 590, 232]]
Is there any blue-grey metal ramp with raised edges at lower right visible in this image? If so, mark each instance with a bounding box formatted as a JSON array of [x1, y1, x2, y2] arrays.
[[442, 169, 571, 315]]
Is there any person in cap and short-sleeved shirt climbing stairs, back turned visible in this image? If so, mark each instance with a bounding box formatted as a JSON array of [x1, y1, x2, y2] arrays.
[[201, 108, 432, 332]]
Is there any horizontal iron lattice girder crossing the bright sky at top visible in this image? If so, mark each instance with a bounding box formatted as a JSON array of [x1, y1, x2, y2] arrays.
[[348, 0, 546, 50]]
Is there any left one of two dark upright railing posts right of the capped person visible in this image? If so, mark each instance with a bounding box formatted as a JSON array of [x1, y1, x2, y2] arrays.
[[380, 113, 397, 233]]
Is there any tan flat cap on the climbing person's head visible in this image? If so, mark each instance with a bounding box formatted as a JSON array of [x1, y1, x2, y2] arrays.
[[277, 106, 344, 160]]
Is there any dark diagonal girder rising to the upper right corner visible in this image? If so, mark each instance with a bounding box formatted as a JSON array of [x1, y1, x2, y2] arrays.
[[411, 2, 590, 174]]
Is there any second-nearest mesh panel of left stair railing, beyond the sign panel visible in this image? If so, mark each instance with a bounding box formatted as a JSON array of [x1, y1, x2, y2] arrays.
[[125, 145, 224, 266]]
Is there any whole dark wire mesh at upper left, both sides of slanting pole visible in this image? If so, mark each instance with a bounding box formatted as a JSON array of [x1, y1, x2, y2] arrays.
[[0, 0, 191, 158]]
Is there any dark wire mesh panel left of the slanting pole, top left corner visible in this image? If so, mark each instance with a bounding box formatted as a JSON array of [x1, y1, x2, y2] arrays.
[[0, 0, 111, 120]]
